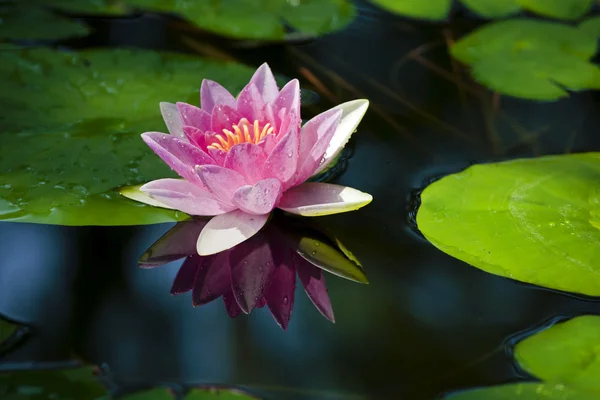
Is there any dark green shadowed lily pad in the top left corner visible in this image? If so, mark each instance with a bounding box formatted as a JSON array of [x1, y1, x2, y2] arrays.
[[0, 4, 89, 40]]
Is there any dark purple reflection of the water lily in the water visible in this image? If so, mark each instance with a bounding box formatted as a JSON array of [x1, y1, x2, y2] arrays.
[[139, 217, 367, 329]]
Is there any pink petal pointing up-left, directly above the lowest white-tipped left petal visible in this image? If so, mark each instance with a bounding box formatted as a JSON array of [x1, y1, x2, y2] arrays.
[[142, 132, 215, 185]]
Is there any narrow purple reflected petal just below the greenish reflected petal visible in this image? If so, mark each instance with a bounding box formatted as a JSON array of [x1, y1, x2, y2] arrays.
[[294, 255, 335, 322]]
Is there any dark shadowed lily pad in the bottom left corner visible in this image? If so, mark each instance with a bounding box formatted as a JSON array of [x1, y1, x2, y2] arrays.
[[0, 367, 108, 400]]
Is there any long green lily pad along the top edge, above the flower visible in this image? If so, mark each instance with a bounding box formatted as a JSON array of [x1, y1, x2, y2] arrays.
[[35, 0, 356, 39]]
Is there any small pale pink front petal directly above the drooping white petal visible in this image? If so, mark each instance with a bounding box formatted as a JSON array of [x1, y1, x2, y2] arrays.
[[233, 178, 282, 215]]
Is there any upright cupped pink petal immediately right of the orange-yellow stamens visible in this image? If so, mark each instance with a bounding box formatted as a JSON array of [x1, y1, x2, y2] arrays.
[[262, 113, 300, 191]]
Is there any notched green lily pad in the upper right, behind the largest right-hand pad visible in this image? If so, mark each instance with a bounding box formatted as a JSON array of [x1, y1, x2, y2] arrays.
[[451, 19, 600, 100]]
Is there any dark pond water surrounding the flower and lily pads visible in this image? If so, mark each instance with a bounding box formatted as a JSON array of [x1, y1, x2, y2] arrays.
[[0, 3, 600, 399]]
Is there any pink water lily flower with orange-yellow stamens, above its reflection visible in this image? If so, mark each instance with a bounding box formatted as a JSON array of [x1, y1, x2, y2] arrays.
[[121, 64, 372, 255]]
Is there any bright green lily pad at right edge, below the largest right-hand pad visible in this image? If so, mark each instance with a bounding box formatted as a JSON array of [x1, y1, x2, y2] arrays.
[[515, 315, 600, 397]]
